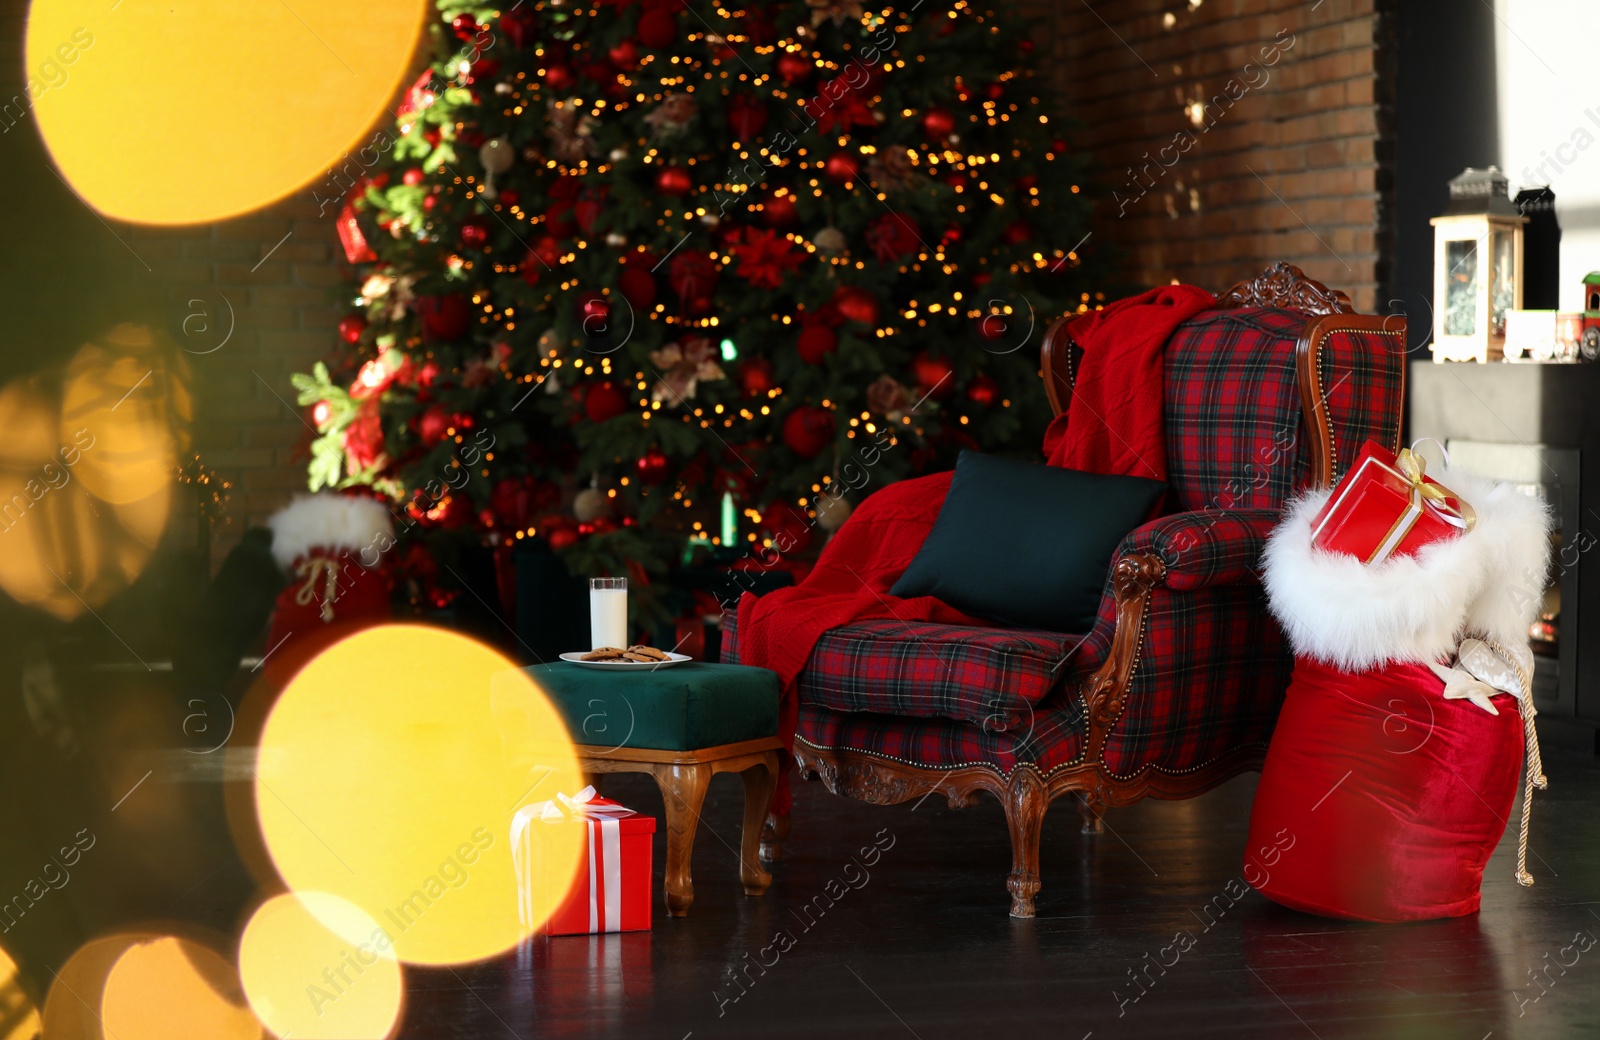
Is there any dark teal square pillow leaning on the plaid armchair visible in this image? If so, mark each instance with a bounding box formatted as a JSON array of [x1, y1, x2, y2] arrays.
[[891, 451, 1166, 632]]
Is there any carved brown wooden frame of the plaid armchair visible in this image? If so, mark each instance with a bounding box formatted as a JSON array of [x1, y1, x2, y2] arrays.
[[782, 264, 1405, 917]]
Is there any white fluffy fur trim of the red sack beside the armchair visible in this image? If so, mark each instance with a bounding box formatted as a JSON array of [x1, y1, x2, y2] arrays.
[[1262, 469, 1550, 672]]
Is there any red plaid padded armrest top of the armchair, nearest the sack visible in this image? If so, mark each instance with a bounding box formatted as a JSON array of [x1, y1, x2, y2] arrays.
[[1112, 509, 1280, 594]]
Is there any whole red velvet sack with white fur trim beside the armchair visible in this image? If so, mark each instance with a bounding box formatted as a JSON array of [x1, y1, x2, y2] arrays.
[[1243, 457, 1549, 922]]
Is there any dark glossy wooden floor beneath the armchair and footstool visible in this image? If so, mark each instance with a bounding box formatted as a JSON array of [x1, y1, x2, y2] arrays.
[[403, 749, 1600, 1040]]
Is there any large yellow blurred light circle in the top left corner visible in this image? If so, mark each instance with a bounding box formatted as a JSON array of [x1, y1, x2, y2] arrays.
[[26, 0, 429, 224]]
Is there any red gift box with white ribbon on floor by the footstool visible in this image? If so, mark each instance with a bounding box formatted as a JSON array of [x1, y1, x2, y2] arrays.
[[510, 787, 656, 936]]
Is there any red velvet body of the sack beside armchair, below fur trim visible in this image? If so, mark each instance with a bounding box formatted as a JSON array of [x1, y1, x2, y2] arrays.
[[1245, 658, 1523, 922]]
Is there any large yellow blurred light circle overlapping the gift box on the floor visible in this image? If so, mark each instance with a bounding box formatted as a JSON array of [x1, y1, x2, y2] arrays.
[[254, 624, 584, 963]]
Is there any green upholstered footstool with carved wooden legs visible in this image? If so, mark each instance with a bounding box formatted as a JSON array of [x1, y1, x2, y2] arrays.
[[523, 661, 782, 917]]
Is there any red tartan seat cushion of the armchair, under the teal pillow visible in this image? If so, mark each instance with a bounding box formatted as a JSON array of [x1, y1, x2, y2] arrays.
[[800, 618, 1083, 733]]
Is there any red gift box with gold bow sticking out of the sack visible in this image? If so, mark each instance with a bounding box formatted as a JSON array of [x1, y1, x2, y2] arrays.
[[1310, 442, 1477, 563]]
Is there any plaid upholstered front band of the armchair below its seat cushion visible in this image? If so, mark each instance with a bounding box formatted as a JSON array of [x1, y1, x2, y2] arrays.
[[797, 698, 1083, 776]]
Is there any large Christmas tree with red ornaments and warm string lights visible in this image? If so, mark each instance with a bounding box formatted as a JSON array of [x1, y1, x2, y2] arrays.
[[296, 0, 1098, 611]]
